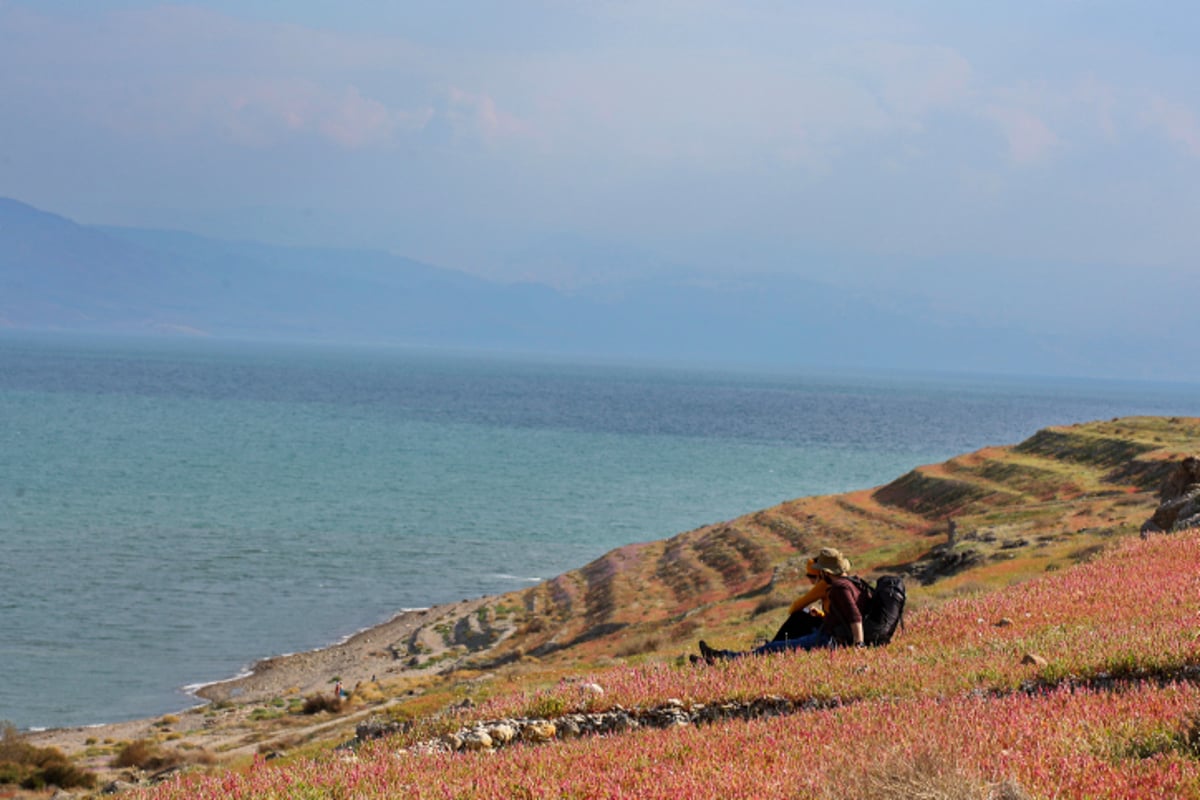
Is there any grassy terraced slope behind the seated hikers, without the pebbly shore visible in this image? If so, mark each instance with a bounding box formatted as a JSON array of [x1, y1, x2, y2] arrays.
[[18, 417, 1200, 796]]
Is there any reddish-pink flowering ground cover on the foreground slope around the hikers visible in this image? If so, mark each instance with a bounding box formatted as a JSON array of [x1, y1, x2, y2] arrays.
[[143, 534, 1200, 800]]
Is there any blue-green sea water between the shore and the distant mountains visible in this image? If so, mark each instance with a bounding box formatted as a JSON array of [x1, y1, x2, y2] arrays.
[[0, 336, 1200, 727]]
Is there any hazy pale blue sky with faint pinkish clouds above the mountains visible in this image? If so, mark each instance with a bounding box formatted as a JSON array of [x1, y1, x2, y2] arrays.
[[0, 0, 1200, 314]]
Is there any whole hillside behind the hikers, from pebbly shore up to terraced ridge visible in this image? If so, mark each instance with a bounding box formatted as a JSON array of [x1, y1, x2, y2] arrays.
[[21, 417, 1200, 796]]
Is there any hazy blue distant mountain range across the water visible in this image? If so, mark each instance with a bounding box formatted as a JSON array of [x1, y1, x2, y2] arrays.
[[0, 198, 1176, 374]]
